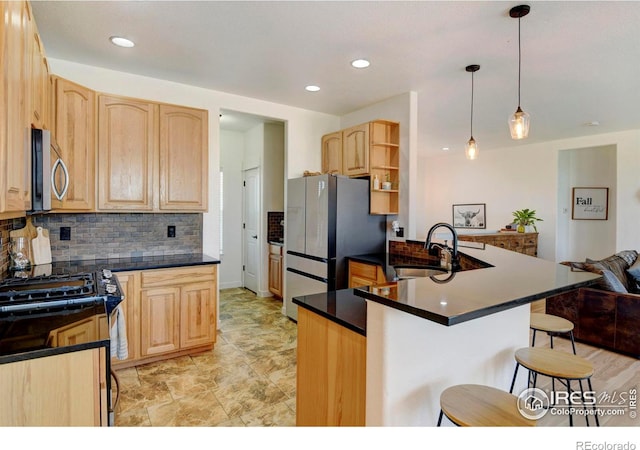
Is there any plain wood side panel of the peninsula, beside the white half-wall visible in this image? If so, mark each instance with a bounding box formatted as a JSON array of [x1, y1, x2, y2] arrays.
[[296, 308, 367, 427]]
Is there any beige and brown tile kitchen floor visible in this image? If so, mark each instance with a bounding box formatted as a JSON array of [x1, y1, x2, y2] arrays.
[[116, 288, 297, 427]]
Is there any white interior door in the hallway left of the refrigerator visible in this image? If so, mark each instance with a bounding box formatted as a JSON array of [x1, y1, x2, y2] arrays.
[[242, 168, 260, 293]]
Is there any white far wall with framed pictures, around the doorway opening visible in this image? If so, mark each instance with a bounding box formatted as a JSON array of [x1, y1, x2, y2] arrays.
[[420, 130, 640, 261]]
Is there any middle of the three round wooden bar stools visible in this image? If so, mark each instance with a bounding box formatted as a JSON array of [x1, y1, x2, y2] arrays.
[[509, 347, 600, 426]]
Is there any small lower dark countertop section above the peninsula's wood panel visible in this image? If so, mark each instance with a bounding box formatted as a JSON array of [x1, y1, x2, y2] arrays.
[[293, 289, 367, 336]]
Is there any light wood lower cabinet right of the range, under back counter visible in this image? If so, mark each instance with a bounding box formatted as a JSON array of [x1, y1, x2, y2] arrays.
[[111, 265, 217, 368]]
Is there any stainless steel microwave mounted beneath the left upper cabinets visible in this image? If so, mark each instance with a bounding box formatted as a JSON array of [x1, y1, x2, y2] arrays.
[[31, 128, 69, 213]]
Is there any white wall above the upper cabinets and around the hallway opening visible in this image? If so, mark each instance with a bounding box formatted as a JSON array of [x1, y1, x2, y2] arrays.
[[48, 58, 339, 257]]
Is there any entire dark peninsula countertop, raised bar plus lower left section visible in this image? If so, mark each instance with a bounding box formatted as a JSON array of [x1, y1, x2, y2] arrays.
[[293, 243, 601, 335]]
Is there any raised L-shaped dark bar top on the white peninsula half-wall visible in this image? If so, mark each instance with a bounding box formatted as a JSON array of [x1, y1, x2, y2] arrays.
[[354, 245, 601, 325]]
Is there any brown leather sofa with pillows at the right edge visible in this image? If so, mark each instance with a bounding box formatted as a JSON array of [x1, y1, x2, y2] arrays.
[[546, 250, 640, 358]]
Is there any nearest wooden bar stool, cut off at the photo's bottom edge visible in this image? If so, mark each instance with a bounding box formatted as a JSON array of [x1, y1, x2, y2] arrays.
[[438, 384, 537, 427]]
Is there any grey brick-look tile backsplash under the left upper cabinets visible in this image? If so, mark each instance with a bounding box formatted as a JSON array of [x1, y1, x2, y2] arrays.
[[0, 213, 202, 271]]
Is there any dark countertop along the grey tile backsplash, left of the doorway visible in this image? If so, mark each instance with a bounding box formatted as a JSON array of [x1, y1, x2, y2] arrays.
[[0, 253, 220, 279]]
